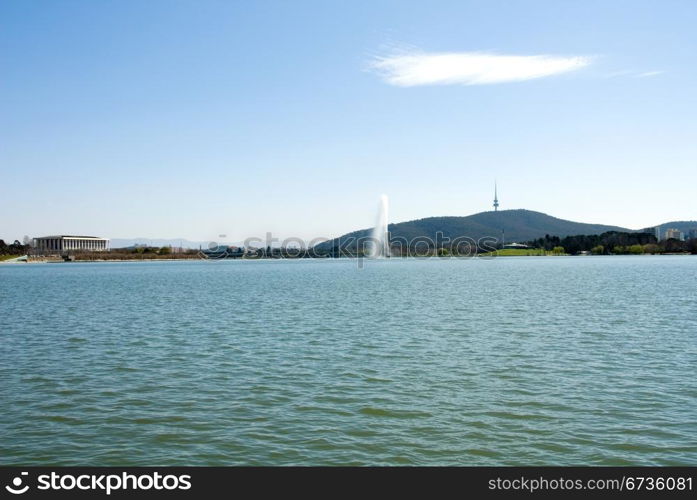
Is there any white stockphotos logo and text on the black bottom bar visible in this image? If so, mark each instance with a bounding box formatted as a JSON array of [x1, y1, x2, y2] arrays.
[[5, 471, 191, 495]]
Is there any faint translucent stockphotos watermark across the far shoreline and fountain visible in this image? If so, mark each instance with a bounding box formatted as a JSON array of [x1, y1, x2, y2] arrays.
[[199, 231, 499, 267]]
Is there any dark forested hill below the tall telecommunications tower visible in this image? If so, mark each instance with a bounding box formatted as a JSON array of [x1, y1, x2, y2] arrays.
[[318, 209, 631, 249]]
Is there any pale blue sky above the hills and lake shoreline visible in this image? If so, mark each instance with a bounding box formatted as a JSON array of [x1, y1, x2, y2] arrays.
[[0, 0, 697, 240]]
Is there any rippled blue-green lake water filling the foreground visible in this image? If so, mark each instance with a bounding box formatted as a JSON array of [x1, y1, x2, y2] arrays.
[[0, 256, 697, 465]]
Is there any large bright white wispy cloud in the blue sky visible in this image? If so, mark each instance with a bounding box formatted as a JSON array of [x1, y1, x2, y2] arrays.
[[370, 51, 592, 87]]
